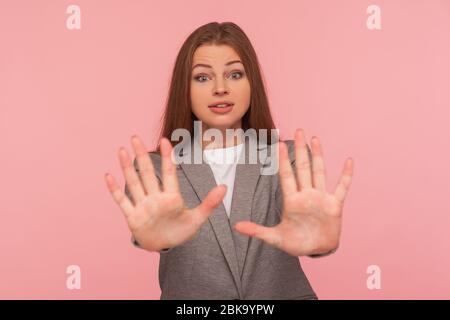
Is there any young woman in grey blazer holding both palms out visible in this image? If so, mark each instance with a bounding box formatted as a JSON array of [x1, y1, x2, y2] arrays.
[[105, 22, 353, 299]]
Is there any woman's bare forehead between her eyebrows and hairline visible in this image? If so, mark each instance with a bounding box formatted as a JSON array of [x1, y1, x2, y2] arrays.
[[193, 44, 240, 65]]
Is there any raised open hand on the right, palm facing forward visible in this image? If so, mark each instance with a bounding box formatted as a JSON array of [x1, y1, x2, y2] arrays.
[[235, 129, 353, 256]]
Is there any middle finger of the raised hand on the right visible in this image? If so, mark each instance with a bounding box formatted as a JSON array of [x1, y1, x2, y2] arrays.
[[295, 129, 312, 191]]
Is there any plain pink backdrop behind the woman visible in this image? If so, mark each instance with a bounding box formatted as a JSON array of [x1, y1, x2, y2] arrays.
[[0, 0, 450, 299]]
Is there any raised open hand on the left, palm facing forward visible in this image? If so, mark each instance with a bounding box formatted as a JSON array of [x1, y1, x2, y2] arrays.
[[105, 135, 226, 251]]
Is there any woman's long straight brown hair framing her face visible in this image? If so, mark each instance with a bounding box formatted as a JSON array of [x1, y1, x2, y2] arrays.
[[156, 22, 275, 152]]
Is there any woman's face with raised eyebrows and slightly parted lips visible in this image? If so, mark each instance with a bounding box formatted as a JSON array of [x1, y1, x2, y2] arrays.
[[191, 45, 251, 134]]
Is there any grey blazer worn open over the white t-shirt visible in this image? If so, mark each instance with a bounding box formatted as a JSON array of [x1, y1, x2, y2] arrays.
[[125, 135, 328, 300]]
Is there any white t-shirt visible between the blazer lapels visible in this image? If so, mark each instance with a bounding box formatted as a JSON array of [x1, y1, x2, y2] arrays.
[[203, 143, 244, 218]]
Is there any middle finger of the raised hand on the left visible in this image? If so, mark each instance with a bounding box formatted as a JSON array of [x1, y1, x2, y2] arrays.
[[131, 135, 161, 194]]
